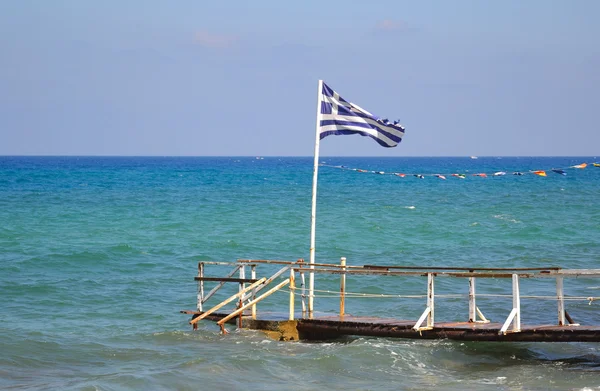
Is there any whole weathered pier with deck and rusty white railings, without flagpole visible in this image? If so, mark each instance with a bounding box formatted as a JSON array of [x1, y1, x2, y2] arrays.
[[181, 258, 600, 342]]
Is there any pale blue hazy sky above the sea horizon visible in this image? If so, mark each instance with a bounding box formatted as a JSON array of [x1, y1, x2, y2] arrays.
[[0, 0, 600, 156]]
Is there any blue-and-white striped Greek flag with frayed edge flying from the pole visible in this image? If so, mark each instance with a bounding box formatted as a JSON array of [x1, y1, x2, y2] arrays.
[[319, 83, 404, 148]]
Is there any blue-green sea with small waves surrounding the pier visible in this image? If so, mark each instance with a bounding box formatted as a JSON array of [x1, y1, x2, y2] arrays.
[[0, 156, 600, 390]]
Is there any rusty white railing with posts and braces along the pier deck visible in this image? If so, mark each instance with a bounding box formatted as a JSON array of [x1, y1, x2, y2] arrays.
[[190, 258, 600, 334]]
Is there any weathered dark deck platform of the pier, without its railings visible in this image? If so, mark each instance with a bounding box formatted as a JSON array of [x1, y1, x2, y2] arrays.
[[181, 311, 600, 342]]
